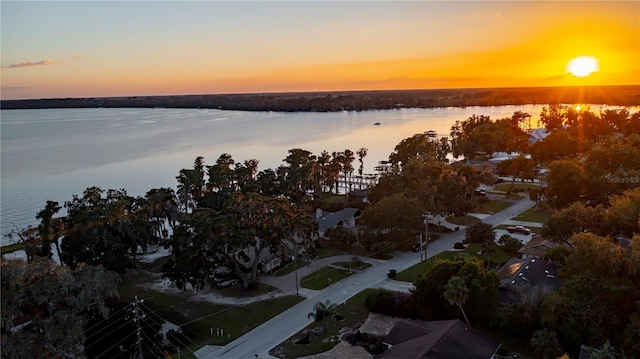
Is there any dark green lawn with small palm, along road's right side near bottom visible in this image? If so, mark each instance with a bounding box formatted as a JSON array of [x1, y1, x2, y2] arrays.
[[269, 289, 375, 358]]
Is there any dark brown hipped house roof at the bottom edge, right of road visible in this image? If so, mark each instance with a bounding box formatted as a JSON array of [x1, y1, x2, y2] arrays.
[[379, 319, 500, 359]]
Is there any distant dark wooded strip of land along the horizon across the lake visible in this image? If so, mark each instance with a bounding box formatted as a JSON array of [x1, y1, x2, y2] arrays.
[[0, 85, 640, 112]]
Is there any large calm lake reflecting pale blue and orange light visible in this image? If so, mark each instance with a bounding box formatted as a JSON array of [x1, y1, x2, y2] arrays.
[[0, 105, 608, 243]]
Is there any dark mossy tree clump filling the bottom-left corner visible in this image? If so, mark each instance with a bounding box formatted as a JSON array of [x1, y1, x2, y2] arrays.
[[0, 260, 118, 359]]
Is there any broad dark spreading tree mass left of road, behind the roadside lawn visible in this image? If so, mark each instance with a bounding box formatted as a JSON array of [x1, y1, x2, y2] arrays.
[[162, 193, 315, 289]]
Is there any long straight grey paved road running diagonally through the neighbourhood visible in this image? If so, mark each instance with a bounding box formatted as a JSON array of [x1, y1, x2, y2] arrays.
[[195, 198, 535, 359]]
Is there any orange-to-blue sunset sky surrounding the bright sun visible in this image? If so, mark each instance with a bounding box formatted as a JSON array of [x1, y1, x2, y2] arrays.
[[0, 0, 640, 99]]
